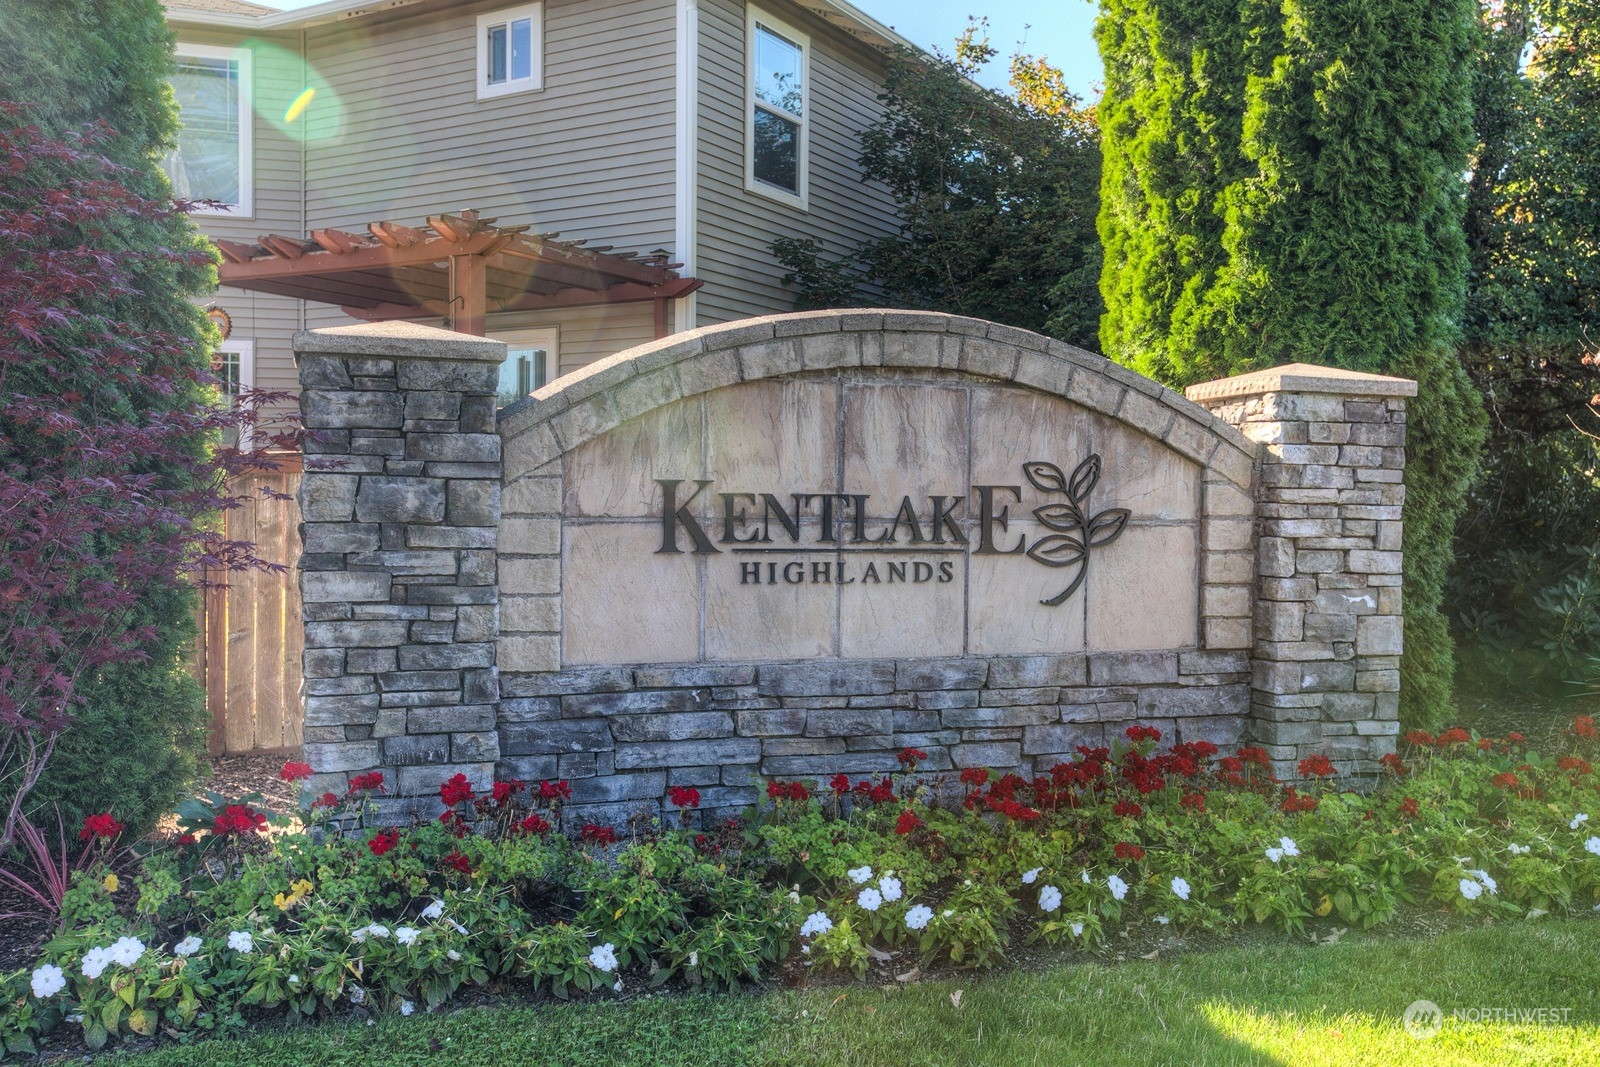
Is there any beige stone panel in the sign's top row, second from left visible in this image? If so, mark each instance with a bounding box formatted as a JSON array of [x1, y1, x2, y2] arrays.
[[699, 379, 838, 521]]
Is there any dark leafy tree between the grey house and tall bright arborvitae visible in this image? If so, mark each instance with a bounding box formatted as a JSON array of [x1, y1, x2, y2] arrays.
[[773, 22, 1101, 346]]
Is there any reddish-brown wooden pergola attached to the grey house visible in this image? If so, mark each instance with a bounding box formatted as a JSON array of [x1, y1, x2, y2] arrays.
[[214, 211, 701, 338]]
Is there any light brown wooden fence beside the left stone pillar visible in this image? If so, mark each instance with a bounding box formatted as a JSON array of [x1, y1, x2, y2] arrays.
[[194, 453, 304, 755]]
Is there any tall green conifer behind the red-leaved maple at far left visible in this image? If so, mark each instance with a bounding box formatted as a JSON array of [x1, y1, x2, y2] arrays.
[[0, 0, 221, 829]]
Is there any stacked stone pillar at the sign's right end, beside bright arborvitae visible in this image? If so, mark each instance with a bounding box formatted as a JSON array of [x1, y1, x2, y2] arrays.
[[1189, 363, 1416, 777]]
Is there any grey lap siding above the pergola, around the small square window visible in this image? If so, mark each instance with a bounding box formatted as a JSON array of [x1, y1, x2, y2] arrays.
[[307, 0, 677, 251]]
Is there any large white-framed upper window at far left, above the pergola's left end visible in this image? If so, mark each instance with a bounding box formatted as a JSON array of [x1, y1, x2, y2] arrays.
[[163, 43, 253, 218]]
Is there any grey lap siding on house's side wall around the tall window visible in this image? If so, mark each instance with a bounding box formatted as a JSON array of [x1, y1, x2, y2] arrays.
[[696, 0, 898, 325]]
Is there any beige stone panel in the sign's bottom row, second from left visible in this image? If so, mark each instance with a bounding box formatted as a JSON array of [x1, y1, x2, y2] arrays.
[[701, 547, 838, 661]]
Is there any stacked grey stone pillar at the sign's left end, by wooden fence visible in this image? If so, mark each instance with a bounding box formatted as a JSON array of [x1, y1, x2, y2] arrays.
[[294, 323, 506, 821]]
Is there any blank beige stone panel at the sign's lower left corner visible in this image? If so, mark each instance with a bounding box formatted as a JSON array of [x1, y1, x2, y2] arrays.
[[562, 523, 699, 664]]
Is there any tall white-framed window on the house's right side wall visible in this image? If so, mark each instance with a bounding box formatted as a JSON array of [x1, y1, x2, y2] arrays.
[[744, 8, 811, 211]]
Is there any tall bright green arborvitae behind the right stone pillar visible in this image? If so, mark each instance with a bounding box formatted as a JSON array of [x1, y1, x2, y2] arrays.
[[1098, 0, 1483, 723]]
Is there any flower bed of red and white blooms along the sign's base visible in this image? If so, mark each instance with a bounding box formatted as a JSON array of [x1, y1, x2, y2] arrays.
[[0, 718, 1600, 1051]]
